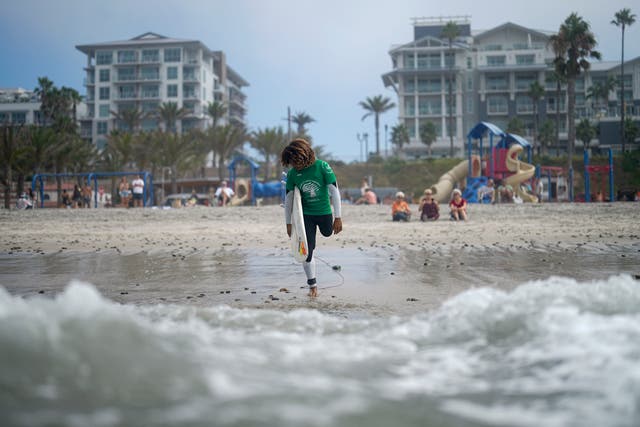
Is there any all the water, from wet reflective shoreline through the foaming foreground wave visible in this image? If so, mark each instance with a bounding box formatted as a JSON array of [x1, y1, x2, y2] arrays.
[[0, 246, 640, 427]]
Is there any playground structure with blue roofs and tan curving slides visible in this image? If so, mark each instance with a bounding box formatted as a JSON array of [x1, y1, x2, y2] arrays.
[[431, 122, 538, 203]]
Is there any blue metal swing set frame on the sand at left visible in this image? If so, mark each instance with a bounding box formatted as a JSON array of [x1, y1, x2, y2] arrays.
[[31, 171, 153, 208]]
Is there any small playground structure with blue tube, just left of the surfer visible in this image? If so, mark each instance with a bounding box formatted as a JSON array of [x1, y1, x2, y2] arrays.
[[227, 155, 285, 206]]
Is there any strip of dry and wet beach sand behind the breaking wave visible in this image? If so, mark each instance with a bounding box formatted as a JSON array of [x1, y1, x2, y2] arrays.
[[0, 203, 640, 316]]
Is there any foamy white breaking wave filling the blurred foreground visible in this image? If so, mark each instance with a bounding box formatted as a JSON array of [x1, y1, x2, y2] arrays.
[[0, 275, 640, 427]]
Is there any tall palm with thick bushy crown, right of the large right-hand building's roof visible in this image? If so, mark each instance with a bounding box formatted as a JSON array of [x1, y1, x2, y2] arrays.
[[551, 12, 601, 177]]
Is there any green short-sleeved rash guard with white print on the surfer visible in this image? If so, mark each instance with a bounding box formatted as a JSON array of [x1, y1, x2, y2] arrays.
[[287, 159, 336, 215]]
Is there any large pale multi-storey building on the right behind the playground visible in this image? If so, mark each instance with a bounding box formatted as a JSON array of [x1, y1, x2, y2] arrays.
[[382, 16, 640, 157]]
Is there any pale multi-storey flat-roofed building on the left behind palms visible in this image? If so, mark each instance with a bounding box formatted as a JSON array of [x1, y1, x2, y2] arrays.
[[76, 32, 249, 148]]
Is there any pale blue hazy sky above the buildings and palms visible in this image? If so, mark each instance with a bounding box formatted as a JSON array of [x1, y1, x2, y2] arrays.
[[0, 0, 640, 161]]
